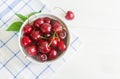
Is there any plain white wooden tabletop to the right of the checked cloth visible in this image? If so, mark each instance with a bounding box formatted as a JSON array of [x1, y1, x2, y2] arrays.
[[43, 0, 120, 79]]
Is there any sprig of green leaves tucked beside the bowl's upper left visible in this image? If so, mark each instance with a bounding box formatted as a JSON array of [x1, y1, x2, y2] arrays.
[[6, 11, 41, 32]]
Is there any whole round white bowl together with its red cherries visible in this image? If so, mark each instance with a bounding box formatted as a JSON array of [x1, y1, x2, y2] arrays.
[[19, 13, 70, 63]]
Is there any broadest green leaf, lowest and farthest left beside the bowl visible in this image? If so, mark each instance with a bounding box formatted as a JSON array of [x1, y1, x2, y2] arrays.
[[7, 22, 23, 32]]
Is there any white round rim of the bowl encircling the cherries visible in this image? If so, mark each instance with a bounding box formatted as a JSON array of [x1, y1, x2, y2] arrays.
[[18, 13, 70, 64]]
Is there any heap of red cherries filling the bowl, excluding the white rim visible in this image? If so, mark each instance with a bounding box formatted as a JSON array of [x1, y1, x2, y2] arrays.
[[21, 17, 68, 62]]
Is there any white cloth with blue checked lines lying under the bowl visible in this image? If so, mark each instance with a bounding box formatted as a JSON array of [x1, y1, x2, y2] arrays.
[[0, 0, 81, 79]]
